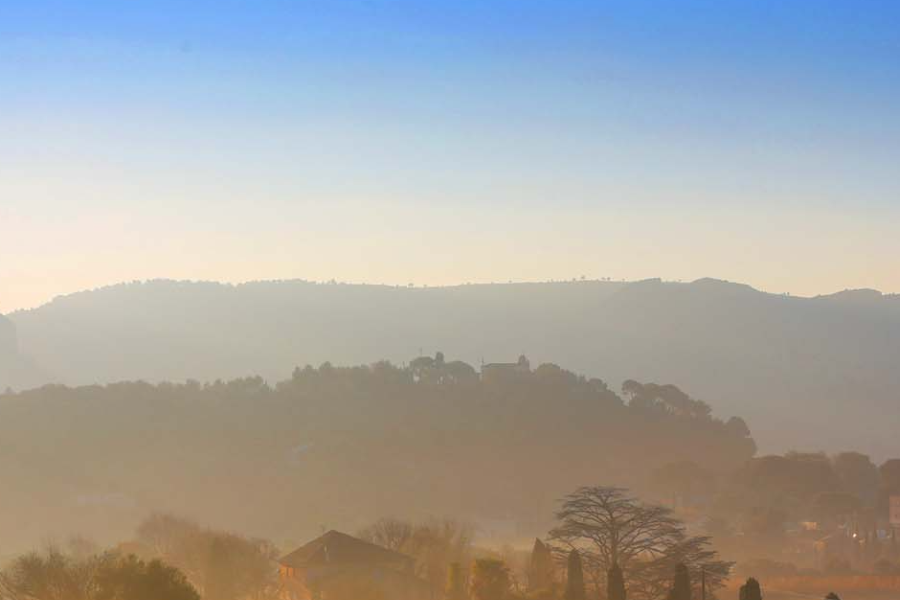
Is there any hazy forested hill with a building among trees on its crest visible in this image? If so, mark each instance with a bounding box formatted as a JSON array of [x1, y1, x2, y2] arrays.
[[0, 358, 754, 552]]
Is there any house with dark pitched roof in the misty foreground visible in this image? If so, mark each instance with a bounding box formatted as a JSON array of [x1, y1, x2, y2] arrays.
[[278, 531, 431, 600]]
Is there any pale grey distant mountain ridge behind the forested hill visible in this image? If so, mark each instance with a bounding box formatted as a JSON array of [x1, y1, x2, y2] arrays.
[[0, 279, 900, 458]]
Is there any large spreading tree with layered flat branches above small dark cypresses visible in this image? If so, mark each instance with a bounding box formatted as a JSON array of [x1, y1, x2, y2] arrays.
[[550, 487, 732, 600]]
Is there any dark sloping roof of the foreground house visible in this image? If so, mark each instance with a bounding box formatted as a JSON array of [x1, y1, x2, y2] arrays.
[[278, 530, 412, 568]]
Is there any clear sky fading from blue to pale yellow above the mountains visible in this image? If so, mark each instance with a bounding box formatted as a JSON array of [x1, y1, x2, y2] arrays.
[[0, 0, 900, 312]]
